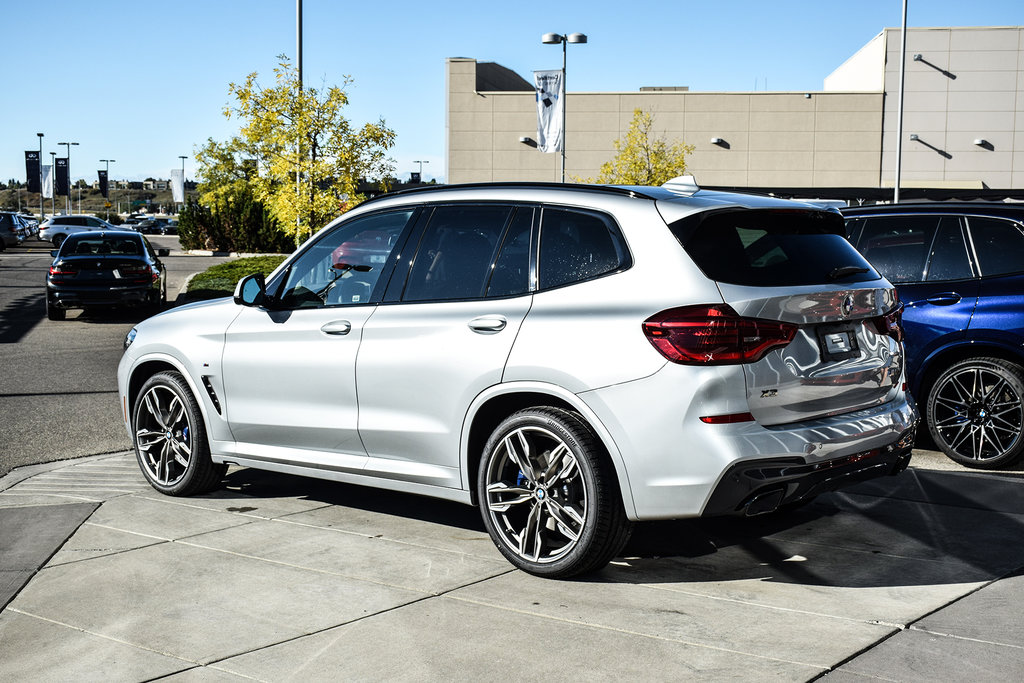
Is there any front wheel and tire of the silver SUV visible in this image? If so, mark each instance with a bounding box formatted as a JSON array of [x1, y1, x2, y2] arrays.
[[132, 372, 227, 496]]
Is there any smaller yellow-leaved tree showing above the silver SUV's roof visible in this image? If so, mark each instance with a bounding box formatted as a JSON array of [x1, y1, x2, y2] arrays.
[[573, 110, 693, 185]]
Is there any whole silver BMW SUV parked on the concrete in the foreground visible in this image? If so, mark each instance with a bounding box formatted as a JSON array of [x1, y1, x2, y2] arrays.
[[118, 180, 918, 577]]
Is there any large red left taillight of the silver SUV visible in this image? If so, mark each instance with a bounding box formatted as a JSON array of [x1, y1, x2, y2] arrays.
[[643, 304, 797, 366]]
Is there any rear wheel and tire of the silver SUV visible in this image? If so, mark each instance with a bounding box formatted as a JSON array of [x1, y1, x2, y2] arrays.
[[476, 408, 633, 579]]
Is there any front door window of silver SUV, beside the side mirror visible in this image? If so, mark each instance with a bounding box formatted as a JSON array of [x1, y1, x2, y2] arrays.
[[276, 209, 413, 308]]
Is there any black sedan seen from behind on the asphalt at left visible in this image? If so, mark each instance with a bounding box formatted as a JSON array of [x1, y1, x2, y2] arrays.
[[46, 230, 168, 321]]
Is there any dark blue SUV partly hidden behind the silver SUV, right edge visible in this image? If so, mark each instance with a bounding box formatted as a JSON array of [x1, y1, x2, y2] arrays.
[[843, 203, 1024, 469]]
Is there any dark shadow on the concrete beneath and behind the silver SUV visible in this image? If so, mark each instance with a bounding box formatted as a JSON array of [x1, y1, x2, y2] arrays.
[[224, 468, 1024, 588]]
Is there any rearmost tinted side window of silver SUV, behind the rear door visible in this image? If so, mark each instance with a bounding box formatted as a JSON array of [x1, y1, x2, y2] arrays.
[[538, 208, 629, 289]]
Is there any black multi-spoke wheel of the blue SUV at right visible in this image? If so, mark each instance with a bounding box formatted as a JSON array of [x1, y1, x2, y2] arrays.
[[927, 358, 1024, 469]]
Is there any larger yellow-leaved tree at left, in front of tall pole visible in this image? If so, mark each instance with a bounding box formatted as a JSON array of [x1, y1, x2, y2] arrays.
[[197, 55, 394, 243]]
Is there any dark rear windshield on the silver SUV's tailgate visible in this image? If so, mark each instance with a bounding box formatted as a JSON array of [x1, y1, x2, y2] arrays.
[[669, 209, 879, 287]]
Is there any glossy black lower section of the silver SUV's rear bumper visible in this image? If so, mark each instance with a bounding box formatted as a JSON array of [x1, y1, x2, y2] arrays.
[[702, 429, 915, 517]]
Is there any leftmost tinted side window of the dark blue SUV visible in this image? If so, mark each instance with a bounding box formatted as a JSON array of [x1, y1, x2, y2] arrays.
[[857, 216, 940, 283]]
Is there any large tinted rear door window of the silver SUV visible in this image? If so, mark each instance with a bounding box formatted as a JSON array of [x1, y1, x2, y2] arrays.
[[401, 205, 512, 301]]
